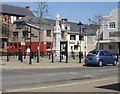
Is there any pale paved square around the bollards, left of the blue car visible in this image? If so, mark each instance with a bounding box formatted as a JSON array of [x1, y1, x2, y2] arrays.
[[0, 57, 84, 69]]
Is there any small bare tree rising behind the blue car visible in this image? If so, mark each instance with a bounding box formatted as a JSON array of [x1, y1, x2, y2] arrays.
[[89, 15, 105, 50]]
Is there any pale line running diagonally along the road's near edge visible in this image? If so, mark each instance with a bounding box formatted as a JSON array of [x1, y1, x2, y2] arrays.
[[6, 78, 113, 92]]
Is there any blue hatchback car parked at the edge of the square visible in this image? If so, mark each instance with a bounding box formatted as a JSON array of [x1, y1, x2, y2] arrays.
[[85, 50, 117, 67]]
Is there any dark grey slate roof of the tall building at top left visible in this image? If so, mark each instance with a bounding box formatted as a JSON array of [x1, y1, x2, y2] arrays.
[[0, 4, 34, 16]]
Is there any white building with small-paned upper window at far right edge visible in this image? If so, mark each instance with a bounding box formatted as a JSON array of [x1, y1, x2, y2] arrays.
[[100, 9, 120, 55]]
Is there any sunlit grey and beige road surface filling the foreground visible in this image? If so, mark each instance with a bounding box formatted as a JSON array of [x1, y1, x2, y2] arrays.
[[2, 66, 118, 92]]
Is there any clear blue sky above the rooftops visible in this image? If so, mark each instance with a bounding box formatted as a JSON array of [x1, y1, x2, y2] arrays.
[[2, 2, 118, 24]]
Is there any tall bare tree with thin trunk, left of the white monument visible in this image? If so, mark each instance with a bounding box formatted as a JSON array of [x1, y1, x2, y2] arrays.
[[34, 1, 49, 62]]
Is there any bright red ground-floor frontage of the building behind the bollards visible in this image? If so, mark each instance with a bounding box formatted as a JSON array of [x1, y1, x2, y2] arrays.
[[3, 42, 53, 54]]
